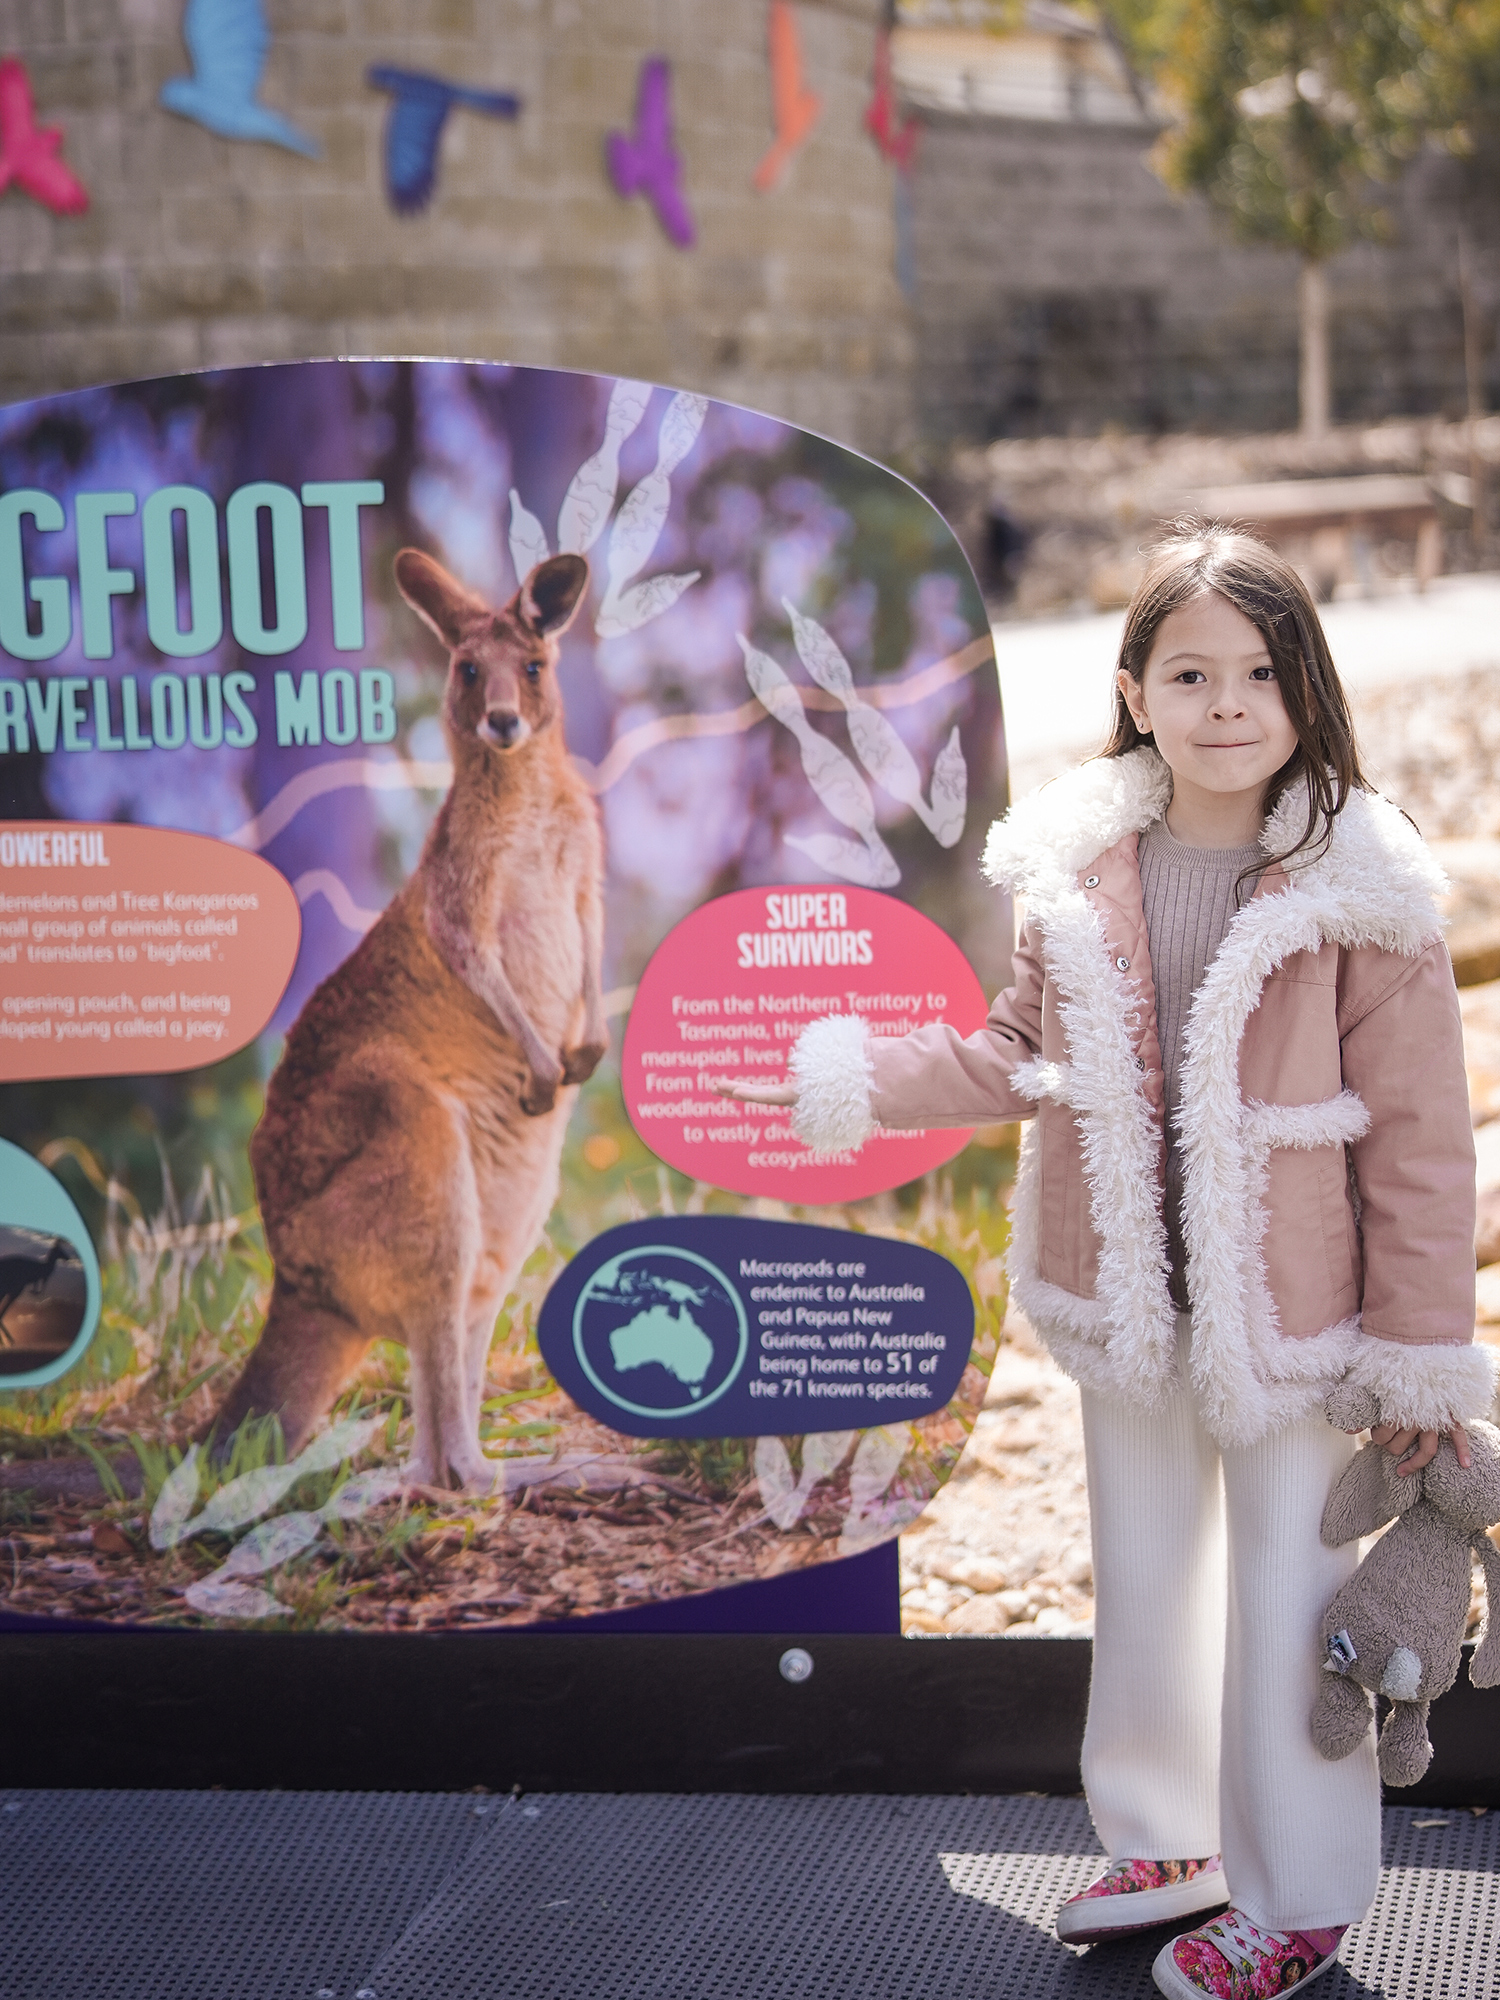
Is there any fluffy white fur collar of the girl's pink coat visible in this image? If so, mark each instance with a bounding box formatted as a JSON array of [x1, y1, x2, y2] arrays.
[[984, 748, 1446, 956]]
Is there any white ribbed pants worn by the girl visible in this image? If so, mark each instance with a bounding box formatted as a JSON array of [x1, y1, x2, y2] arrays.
[[1082, 1314, 1380, 1930]]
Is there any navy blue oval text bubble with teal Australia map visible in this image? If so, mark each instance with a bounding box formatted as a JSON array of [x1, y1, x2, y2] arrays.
[[538, 1216, 974, 1438]]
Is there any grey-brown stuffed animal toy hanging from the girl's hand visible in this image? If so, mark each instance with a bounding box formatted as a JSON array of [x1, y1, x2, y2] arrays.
[[1312, 1384, 1500, 1784]]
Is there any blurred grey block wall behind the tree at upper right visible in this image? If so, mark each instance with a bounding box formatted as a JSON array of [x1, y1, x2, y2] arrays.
[[912, 112, 1500, 440]]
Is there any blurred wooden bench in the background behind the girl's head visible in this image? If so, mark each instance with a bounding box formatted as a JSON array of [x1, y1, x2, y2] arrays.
[[1192, 472, 1442, 600]]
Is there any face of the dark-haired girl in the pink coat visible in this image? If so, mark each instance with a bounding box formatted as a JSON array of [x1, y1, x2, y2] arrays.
[[1118, 590, 1296, 796]]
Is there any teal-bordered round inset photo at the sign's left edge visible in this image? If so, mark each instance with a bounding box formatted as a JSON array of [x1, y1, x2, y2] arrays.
[[0, 1138, 100, 1394]]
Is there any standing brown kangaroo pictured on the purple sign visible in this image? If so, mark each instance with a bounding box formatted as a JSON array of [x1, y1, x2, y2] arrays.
[[216, 548, 608, 1492]]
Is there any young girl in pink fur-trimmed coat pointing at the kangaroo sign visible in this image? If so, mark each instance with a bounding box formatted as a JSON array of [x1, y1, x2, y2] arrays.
[[732, 528, 1494, 2000]]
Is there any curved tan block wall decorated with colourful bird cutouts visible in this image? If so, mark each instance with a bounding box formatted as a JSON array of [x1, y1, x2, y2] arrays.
[[0, 0, 912, 452]]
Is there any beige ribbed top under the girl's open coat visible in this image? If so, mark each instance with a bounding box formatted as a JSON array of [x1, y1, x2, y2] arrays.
[[1140, 820, 1262, 1312]]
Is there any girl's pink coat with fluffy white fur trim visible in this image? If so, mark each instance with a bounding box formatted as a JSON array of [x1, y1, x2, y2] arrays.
[[792, 748, 1494, 1444]]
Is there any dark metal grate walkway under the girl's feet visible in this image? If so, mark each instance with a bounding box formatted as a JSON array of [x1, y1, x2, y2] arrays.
[[0, 1792, 1500, 2000]]
